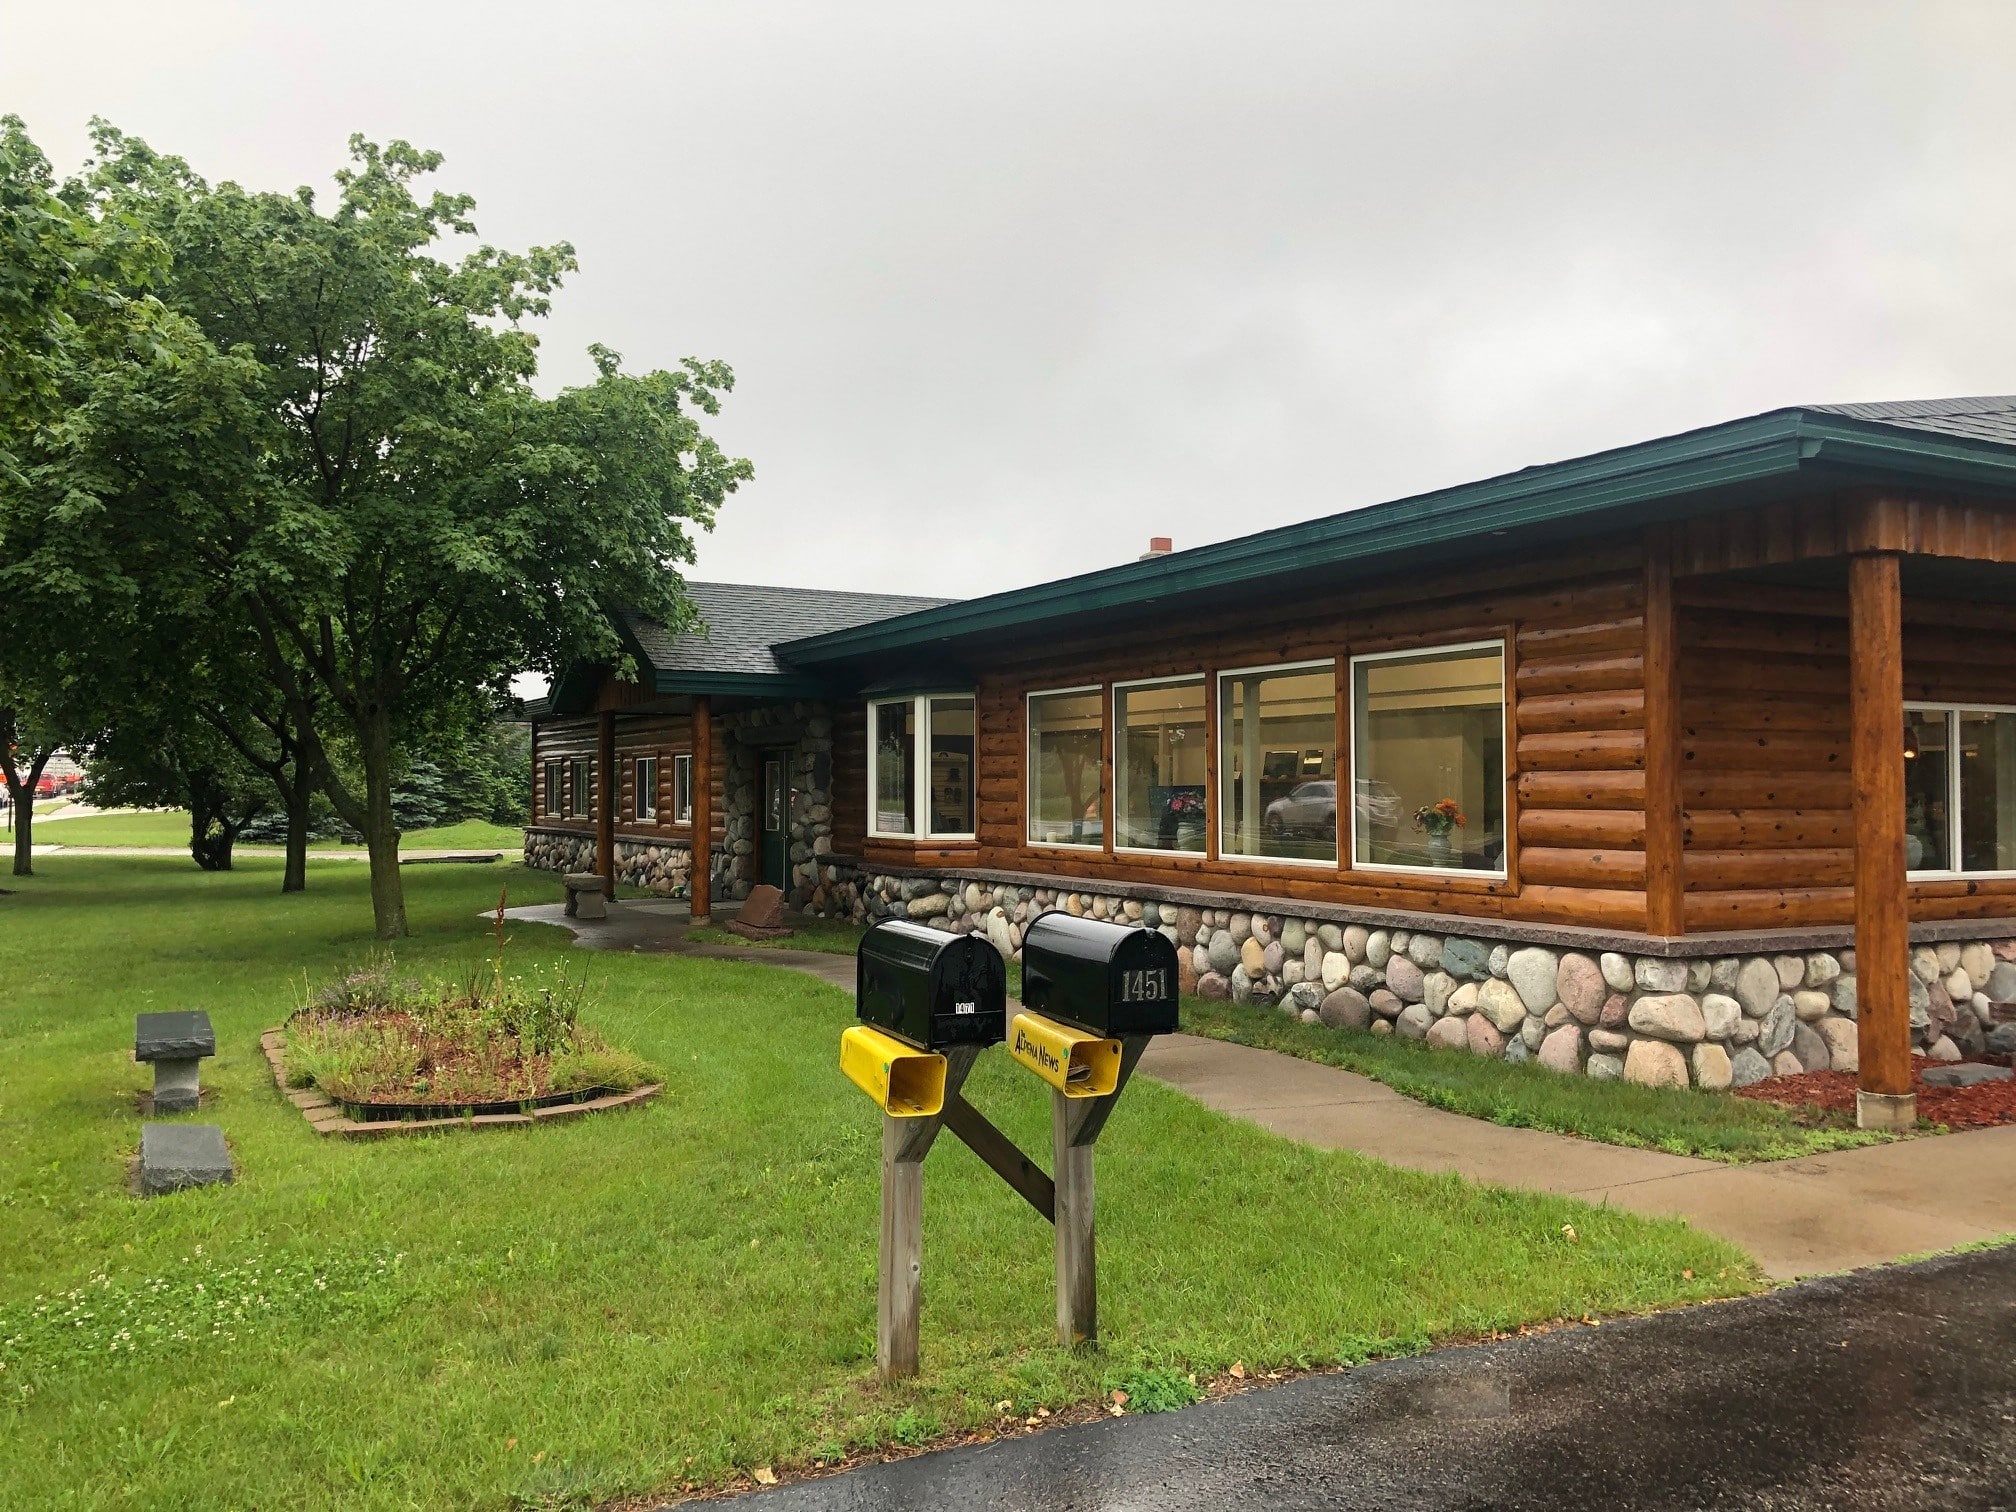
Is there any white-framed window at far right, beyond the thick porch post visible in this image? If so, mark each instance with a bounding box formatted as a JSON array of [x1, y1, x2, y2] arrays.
[[1903, 704, 2016, 877]]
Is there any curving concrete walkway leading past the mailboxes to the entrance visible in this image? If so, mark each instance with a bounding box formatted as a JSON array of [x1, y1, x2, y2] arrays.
[[516, 901, 2016, 1280]]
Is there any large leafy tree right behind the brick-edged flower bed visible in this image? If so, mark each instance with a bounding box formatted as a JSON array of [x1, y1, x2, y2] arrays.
[[77, 125, 750, 937]]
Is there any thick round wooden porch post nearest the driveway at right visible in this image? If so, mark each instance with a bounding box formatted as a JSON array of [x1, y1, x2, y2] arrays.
[[1849, 552, 1917, 1129]]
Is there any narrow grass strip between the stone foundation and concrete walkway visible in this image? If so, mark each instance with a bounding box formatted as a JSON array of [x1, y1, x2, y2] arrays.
[[1183, 998, 1891, 1161]]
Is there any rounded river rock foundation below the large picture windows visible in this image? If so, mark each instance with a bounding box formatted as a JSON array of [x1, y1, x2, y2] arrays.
[[806, 867, 2016, 1091]]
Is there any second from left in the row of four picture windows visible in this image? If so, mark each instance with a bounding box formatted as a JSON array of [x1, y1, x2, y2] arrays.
[[1113, 677, 1210, 853]]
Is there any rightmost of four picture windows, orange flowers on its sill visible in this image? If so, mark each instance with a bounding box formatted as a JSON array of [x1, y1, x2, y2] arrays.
[[1351, 641, 1506, 875]]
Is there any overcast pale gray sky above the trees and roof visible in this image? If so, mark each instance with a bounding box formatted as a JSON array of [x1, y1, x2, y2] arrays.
[[0, 0, 2016, 595]]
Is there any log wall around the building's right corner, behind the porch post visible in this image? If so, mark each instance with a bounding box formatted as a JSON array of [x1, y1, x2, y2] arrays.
[[1679, 579, 2016, 931]]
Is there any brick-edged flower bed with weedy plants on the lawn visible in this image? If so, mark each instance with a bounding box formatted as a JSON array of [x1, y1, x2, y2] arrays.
[[282, 958, 655, 1119]]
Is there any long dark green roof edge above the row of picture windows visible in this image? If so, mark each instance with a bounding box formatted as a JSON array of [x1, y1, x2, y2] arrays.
[[776, 399, 2016, 667]]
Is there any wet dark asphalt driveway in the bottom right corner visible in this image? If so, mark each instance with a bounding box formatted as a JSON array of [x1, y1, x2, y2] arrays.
[[725, 1248, 2016, 1512]]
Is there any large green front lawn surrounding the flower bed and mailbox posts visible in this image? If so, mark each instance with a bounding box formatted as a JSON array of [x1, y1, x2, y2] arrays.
[[0, 855, 1756, 1508]]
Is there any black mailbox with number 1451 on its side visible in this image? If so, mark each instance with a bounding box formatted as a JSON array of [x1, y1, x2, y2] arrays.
[[1022, 913, 1175, 1038]]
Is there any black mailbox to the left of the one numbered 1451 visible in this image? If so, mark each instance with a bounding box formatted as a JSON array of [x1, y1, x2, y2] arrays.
[[855, 919, 1008, 1050]]
